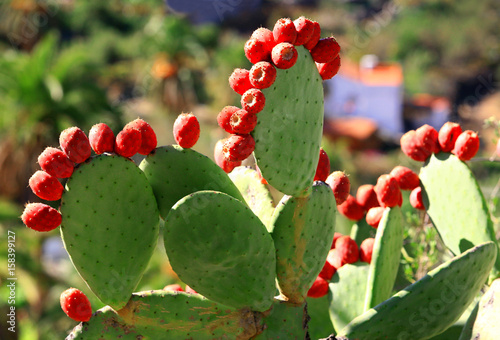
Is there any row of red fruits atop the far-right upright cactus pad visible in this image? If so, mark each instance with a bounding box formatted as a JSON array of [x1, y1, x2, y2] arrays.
[[401, 122, 479, 162]]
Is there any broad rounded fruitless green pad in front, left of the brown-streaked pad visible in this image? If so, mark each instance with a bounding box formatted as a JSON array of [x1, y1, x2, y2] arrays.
[[164, 191, 276, 311]]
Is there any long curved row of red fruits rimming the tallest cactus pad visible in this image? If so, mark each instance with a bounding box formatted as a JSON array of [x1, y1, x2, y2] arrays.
[[214, 17, 340, 173]]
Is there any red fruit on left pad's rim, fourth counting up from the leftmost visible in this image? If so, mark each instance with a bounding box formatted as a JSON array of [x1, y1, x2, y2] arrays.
[[59, 126, 92, 163]]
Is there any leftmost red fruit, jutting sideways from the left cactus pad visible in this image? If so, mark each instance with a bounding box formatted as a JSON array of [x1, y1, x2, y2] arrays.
[[21, 203, 62, 232]]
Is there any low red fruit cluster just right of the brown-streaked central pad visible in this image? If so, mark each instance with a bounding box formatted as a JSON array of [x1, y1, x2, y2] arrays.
[[307, 233, 375, 298]]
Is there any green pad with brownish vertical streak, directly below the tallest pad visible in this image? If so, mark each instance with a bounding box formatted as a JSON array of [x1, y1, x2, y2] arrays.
[[271, 182, 337, 303]]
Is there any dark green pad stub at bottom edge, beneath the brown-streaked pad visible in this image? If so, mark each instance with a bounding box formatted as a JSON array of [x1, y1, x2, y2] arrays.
[[255, 300, 307, 340]]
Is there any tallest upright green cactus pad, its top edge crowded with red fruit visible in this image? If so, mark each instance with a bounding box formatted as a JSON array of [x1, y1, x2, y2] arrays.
[[252, 46, 323, 196]]
